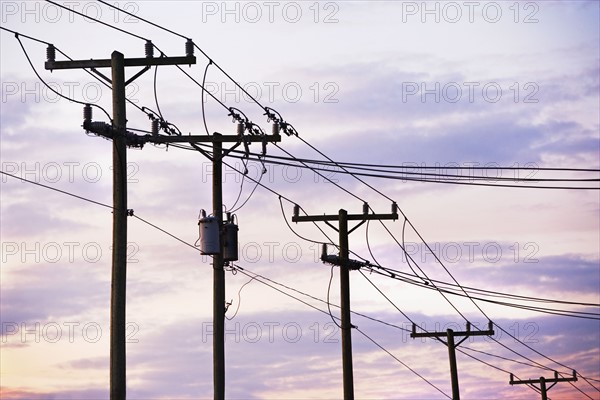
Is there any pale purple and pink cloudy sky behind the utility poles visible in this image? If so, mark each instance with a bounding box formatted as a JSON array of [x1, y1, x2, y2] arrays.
[[0, 0, 600, 400]]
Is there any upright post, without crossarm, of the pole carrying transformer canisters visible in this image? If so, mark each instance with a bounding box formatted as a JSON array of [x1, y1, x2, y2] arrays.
[[212, 133, 225, 400]]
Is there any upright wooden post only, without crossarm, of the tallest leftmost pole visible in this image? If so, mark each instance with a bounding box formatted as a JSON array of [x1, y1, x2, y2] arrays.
[[110, 51, 127, 400]]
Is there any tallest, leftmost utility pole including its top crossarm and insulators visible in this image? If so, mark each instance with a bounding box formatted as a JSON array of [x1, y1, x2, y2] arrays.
[[45, 41, 196, 400]]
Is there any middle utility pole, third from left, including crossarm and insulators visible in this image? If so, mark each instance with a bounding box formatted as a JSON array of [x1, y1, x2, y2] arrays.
[[292, 203, 398, 400]]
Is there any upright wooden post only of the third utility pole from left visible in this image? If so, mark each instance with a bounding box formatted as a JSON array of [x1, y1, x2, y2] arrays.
[[338, 209, 354, 400]]
